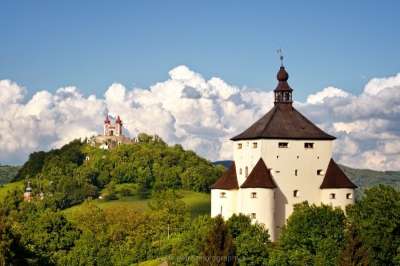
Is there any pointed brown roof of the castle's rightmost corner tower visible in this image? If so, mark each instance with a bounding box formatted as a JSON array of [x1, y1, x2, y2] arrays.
[[320, 159, 357, 189]]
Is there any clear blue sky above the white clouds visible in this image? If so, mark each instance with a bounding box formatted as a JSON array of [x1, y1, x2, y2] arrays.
[[0, 0, 400, 100]]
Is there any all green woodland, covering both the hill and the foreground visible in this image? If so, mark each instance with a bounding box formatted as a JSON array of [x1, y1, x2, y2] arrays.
[[0, 134, 400, 266]]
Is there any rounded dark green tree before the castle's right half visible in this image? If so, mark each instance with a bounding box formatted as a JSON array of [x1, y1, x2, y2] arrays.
[[280, 202, 345, 265]]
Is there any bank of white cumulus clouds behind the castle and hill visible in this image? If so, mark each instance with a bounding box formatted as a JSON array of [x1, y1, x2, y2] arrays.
[[0, 65, 400, 169]]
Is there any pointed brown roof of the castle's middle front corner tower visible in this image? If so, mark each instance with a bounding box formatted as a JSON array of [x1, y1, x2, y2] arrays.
[[240, 159, 276, 188]]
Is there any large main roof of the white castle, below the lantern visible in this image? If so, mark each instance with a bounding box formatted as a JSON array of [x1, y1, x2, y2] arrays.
[[231, 104, 335, 140]]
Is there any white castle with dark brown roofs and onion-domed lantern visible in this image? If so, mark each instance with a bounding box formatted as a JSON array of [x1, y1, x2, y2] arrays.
[[211, 66, 356, 241]]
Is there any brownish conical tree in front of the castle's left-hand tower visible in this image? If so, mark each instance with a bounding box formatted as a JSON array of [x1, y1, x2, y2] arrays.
[[199, 216, 236, 266]]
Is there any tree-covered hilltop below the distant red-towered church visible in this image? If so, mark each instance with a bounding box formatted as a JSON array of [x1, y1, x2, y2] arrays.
[[16, 134, 223, 209]]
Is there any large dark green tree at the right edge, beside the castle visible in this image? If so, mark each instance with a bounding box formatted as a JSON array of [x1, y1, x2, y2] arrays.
[[347, 185, 400, 265]]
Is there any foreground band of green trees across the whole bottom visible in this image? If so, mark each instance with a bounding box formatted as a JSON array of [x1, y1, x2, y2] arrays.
[[0, 186, 400, 266]]
